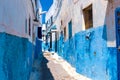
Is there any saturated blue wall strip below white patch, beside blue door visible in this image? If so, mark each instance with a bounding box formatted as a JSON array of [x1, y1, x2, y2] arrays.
[[106, 47, 118, 80]]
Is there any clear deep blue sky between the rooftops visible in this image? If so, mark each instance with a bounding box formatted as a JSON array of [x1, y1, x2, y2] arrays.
[[40, 0, 53, 23]]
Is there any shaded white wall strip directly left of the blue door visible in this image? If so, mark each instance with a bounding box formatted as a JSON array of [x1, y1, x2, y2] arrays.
[[106, 0, 120, 47]]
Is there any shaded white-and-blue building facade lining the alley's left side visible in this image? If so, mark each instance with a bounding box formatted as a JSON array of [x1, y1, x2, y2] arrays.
[[0, 0, 41, 80]]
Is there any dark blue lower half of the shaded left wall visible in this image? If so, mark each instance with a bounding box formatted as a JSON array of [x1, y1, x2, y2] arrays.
[[0, 33, 34, 80]]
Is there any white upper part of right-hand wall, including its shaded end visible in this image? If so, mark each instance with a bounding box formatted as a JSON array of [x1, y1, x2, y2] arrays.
[[48, 0, 120, 47]]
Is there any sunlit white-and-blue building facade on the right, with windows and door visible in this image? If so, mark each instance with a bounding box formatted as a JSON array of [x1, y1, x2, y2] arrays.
[[46, 0, 120, 80]]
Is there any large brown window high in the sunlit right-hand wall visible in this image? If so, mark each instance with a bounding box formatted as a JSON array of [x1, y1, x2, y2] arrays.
[[83, 4, 93, 29]]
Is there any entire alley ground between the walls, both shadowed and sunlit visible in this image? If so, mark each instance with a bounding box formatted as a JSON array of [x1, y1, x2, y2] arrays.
[[30, 52, 91, 80]]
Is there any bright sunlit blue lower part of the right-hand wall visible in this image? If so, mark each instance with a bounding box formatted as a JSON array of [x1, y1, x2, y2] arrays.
[[53, 26, 117, 80]]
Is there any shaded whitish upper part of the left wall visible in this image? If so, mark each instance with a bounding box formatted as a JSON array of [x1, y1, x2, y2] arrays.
[[0, 0, 35, 37]]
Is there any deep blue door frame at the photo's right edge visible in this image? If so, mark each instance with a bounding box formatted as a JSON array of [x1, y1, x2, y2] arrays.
[[115, 7, 120, 80]]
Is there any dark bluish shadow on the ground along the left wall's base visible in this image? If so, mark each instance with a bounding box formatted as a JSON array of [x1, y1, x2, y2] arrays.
[[30, 54, 54, 80]]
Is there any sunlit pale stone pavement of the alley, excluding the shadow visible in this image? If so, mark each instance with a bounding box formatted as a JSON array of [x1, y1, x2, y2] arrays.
[[43, 52, 91, 80]]
